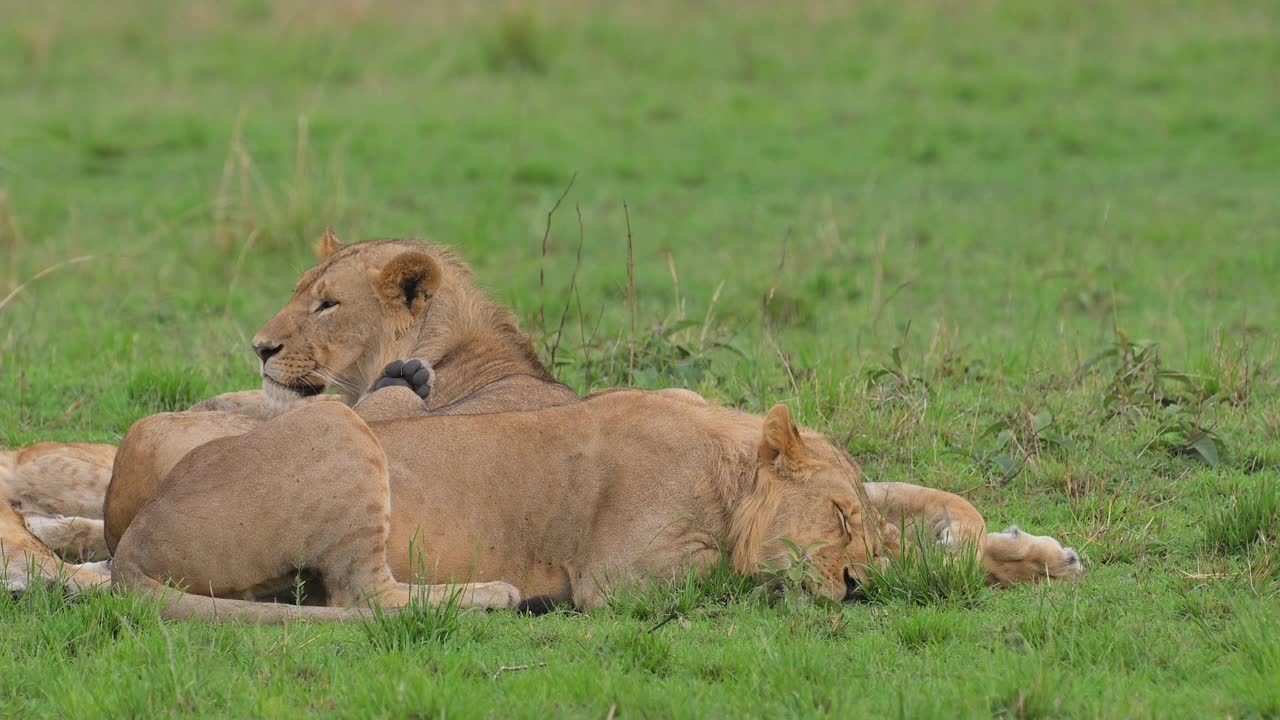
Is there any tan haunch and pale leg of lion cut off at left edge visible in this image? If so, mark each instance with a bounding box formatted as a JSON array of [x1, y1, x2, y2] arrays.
[[0, 442, 115, 562]]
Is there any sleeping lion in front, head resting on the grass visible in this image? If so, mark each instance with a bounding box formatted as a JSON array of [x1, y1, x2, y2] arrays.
[[113, 391, 886, 623]]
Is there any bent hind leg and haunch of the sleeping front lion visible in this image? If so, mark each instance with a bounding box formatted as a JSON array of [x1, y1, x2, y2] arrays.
[[115, 402, 520, 607]]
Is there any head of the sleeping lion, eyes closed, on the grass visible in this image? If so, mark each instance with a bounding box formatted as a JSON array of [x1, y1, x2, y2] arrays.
[[731, 405, 892, 600]]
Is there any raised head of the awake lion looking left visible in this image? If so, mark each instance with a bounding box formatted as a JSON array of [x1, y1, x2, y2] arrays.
[[253, 231, 468, 402]]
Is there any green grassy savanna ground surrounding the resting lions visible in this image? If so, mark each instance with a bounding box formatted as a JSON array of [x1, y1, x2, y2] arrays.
[[0, 0, 1280, 717]]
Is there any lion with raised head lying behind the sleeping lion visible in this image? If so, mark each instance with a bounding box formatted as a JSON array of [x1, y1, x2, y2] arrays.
[[104, 231, 579, 552]]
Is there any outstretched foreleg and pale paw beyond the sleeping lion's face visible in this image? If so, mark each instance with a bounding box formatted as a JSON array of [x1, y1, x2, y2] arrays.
[[865, 483, 1084, 587]]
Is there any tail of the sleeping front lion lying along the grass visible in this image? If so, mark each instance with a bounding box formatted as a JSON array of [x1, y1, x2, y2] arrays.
[[111, 562, 372, 625]]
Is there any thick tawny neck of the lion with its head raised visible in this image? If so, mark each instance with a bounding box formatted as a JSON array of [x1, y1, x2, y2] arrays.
[[396, 287, 557, 407]]
